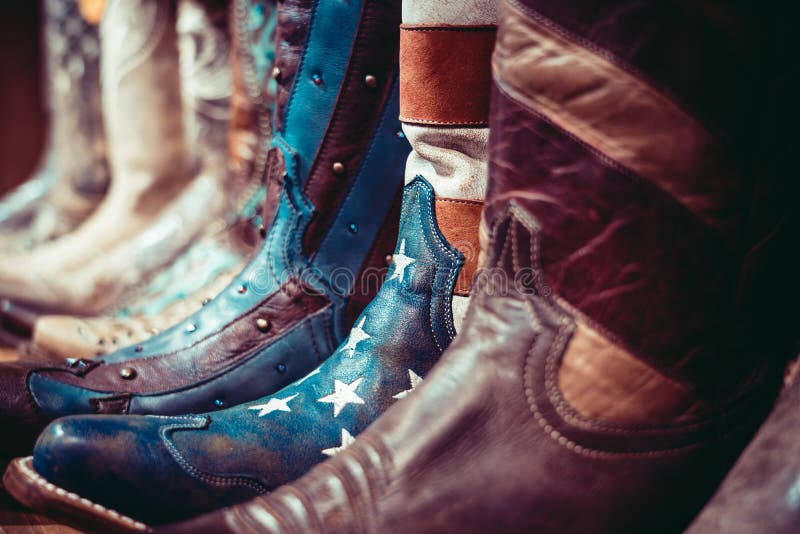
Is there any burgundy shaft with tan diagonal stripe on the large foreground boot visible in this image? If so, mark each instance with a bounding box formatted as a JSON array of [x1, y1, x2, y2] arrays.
[[485, 0, 788, 404]]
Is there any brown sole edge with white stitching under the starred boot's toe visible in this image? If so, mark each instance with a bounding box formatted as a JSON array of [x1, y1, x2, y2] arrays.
[[3, 456, 151, 532]]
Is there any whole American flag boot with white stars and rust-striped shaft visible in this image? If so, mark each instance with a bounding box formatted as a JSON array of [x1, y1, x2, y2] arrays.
[[0, 1, 496, 529]]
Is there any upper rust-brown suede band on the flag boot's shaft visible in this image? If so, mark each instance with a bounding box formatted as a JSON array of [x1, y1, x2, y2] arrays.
[[400, 24, 497, 126]]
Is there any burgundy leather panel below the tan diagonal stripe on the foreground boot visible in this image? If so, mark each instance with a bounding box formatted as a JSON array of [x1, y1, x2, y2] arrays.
[[484, 91, 743, 394]]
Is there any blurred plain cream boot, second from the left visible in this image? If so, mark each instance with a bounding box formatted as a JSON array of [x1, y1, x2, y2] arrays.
[[0, 1, 227, 314]]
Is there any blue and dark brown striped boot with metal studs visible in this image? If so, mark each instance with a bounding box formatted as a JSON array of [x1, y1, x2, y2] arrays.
[[0, 0, 409, 482]]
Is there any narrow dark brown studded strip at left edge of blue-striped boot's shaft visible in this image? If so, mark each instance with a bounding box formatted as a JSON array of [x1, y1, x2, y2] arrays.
[[273, 0, 315, 131]]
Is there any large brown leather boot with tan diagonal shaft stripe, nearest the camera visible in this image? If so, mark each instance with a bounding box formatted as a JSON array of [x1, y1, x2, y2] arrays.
[[161, 0, 786, 532]]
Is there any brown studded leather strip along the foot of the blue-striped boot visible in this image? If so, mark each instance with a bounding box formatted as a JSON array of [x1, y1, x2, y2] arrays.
[[40, 279, 329, 393]]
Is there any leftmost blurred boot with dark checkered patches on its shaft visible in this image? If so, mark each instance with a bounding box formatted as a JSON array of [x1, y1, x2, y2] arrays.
[[0, 0, 109, 252]]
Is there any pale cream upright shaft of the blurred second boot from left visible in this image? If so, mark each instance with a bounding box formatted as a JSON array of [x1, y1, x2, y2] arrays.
[[100, 0, 189, 203]]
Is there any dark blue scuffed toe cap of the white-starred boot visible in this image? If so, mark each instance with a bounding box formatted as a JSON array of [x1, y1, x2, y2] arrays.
[[33, 416, 260, 525]]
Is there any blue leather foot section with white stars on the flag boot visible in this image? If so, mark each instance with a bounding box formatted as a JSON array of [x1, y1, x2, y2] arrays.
[[33, 178, 463, 525]]
